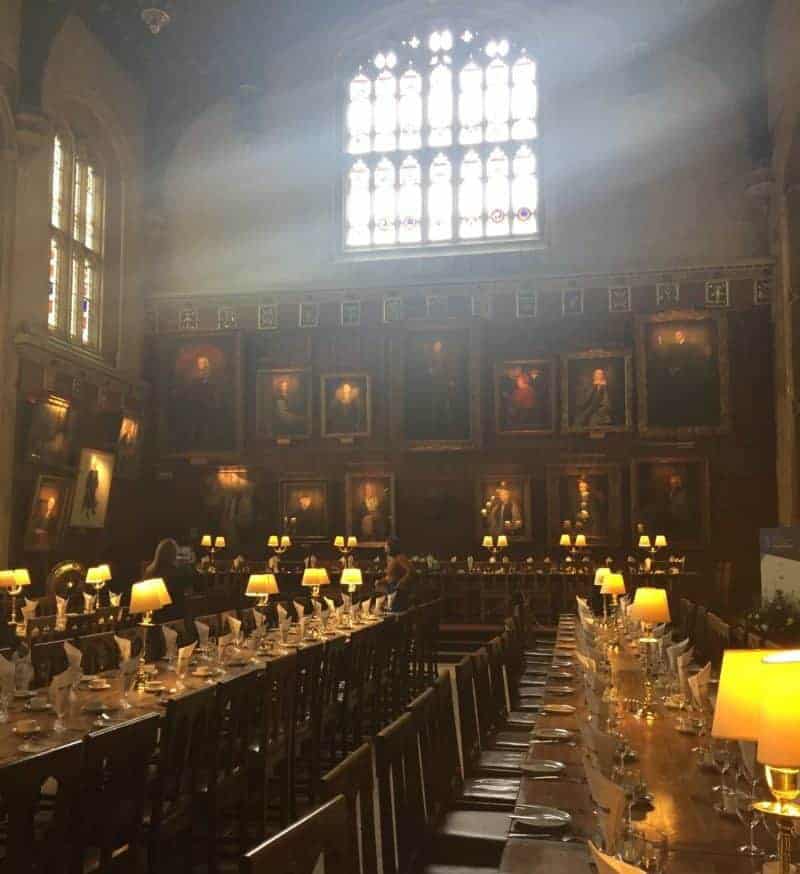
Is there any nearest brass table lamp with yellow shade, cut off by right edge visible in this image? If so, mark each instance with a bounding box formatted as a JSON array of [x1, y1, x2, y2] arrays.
[[753, 650, 800, 874]]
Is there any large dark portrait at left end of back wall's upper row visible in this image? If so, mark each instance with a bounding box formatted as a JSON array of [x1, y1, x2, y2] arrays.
[[161, 334, 241, 455]]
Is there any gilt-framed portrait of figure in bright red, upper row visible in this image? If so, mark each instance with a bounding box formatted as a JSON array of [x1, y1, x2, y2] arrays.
[[494, 359, 556, 434]]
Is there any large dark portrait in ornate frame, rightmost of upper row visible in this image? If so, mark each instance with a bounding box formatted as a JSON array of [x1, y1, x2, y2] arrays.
[[637, 312, 729, 437]]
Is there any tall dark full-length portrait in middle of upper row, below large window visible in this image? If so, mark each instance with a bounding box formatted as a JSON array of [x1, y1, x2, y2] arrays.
[[404, 331, 472, 443]]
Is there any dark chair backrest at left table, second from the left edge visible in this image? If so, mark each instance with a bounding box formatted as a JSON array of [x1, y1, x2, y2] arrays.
[[78, 713, 160, 871]]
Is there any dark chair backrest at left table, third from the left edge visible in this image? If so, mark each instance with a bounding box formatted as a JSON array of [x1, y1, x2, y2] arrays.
[[153, 687, 215, 824]]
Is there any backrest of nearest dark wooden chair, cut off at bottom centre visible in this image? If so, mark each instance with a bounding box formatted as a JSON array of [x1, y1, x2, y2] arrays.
[[240, 795, 358, 874]]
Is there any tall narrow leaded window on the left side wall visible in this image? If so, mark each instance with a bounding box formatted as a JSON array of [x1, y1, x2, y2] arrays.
[[47, 131, 104, 349]]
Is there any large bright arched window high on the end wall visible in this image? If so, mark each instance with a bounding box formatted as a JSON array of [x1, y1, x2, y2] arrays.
[[344, 28, 540, 251]]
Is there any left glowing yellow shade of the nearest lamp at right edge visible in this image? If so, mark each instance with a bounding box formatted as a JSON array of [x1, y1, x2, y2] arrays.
[[711, 649, 774, 741]]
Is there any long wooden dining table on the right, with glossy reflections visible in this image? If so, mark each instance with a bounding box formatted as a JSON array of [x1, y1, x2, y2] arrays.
[[500, 617, 774, 874]]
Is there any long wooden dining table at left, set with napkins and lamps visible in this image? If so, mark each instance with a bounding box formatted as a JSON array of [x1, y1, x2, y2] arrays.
[[0, 618, 383, 768]]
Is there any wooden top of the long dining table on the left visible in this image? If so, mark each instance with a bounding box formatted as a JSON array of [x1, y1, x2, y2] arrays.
[[0, 623, 375, 767]]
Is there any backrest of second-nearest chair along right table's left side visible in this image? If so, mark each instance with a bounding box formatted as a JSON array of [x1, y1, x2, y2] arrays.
[[322, 744, 378, 874]]
